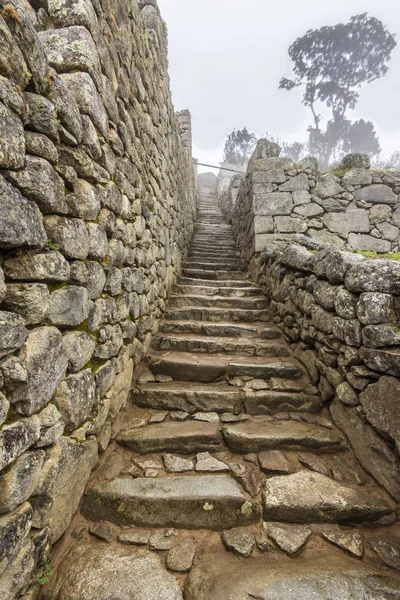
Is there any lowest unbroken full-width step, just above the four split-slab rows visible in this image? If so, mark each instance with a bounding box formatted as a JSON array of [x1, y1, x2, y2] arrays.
[[153, 333, 291, 357]]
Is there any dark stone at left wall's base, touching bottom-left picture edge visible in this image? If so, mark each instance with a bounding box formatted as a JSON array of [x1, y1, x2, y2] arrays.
[[0, 502, 32, 575]]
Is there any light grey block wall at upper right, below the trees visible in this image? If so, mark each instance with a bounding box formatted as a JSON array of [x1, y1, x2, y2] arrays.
[[220, 140, 400, 274]]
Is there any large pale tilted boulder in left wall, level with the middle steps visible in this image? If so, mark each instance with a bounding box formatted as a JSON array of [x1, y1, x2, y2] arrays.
[[8, 327, 68, 415]]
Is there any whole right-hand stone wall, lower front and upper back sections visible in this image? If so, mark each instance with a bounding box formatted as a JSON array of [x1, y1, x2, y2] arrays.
[[220, 142, 400, 510]]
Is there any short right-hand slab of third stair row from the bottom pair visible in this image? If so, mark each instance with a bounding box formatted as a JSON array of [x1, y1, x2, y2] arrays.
[[245, 390, 323, 415]]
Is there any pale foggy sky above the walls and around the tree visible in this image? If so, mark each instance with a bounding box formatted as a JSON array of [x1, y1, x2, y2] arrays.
[[158, 0, 400, 170]]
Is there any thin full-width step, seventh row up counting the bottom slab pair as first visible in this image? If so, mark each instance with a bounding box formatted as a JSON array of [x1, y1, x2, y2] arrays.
[[165, 306, 272, 322]]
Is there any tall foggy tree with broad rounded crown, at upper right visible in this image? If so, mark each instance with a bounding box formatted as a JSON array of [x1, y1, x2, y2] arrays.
[[279, 13, 396, 166]]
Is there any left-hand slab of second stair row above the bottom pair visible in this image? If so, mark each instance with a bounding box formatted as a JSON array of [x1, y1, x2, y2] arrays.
[[117, 417, 222, 454]]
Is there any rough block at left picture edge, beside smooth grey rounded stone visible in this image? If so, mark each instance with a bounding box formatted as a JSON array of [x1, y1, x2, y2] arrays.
[[4, 283, 50, 325]]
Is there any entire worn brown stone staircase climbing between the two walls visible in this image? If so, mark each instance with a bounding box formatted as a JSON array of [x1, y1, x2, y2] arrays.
[[44, 197, 400, 600]]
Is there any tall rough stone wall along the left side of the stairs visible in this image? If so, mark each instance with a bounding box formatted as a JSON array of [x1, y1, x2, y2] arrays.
[[0, 0, 195, 600]]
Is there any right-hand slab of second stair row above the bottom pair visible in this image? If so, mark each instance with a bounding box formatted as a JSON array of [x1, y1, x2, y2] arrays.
[[223, 418, 346, 454]]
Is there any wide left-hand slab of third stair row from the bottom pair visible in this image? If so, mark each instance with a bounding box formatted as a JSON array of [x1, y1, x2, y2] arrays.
[[132, 381, 244, 414]]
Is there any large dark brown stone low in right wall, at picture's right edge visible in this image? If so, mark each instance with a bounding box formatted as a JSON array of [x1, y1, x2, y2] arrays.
[[360, 376, 400, 450]]
